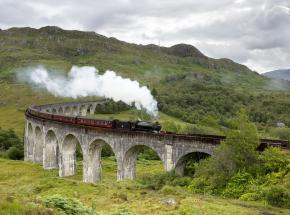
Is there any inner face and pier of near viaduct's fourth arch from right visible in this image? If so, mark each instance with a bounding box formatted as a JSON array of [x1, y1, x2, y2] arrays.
[[59, 134, 85, 177]]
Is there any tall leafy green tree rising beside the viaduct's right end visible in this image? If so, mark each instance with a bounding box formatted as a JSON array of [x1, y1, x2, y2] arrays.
[[191, 110, 259, 190]]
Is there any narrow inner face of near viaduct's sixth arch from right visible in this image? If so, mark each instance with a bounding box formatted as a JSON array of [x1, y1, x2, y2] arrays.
[[33, 126, 43, 163]]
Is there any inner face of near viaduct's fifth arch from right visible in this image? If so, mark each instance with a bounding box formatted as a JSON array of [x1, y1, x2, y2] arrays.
[[43, 130, 59, 169]]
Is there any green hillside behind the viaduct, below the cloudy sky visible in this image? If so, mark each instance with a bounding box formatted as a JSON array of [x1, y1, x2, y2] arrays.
[[0, 26, 290, 125]]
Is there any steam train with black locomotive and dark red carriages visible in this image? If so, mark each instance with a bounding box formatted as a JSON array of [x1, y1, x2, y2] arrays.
[[26, 107, 161, 133]]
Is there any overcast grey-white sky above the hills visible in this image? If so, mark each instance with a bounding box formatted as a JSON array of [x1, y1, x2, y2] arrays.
[[0, 0, 290, 73]]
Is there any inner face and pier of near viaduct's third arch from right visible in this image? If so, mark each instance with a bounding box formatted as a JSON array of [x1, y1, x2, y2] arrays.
[[84, 138, 116, 183]]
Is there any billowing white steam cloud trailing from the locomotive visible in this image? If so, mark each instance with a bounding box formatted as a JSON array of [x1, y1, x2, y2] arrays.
[[21, 66, 158, 116]]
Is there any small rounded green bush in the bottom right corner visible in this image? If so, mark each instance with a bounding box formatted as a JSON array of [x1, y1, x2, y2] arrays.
[[265, 185, 290, 207]]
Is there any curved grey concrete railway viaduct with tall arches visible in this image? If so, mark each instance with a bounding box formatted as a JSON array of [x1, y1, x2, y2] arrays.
[[24, 101, 288, 183]]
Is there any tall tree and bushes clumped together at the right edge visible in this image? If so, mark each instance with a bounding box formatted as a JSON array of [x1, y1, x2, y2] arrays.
[[189, 111, 290, 208]]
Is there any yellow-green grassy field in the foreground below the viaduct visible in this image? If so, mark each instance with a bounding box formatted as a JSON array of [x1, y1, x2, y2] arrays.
[[0, 158, 290, 215]]
